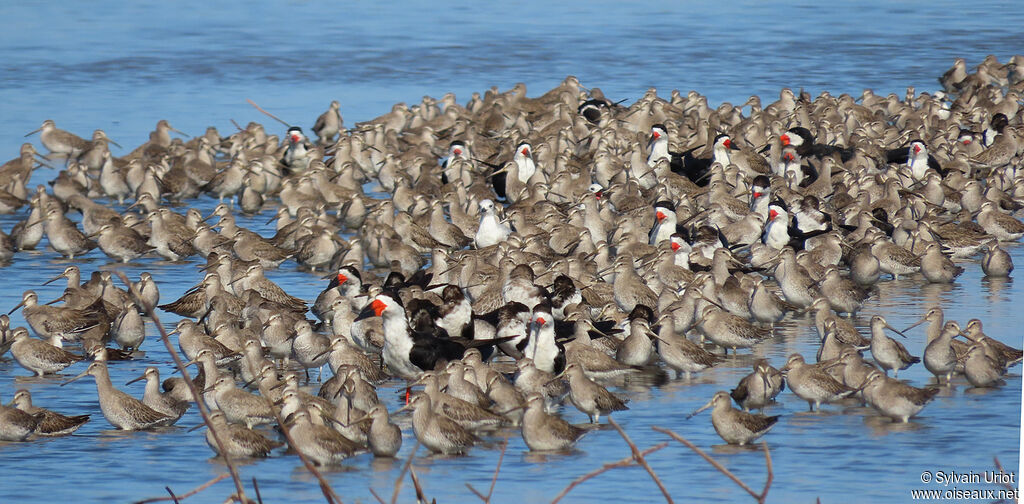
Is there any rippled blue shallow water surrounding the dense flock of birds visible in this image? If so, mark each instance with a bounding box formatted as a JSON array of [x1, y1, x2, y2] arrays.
[[0, 1, 1024, 502]]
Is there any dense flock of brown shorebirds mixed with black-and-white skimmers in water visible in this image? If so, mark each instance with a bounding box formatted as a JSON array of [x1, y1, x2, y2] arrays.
[[0, 55, 1024, 464]]
